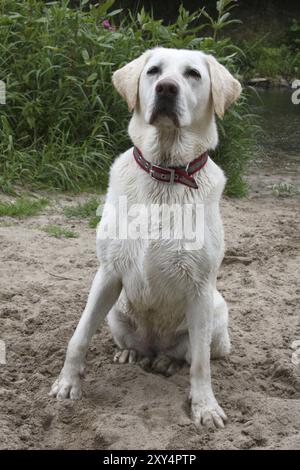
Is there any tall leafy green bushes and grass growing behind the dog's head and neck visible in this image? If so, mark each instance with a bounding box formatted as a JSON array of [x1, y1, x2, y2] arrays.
[[0, 0, 255, 195]]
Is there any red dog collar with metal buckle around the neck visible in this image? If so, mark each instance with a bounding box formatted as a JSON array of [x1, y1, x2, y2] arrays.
[[133, 146, 208, 189]]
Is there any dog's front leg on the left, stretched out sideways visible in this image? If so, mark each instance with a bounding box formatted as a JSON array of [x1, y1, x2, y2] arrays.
[[50, 268, 122, 399]]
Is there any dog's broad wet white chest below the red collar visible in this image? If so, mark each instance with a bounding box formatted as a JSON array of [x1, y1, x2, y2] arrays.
[[97, 151, 222, 310]]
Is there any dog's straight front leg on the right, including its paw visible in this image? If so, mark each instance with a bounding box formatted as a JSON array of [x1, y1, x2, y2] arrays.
[[187, 284, 227, 428]]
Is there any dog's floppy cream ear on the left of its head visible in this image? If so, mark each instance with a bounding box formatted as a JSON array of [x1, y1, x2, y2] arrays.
[[112, 51, 150, 111]]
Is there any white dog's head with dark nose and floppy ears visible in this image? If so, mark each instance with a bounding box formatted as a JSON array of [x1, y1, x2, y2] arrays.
[[113, 48, 241, 127]]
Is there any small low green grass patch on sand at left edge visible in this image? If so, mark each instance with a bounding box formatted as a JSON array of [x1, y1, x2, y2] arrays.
[[0, 197, 49, 219]]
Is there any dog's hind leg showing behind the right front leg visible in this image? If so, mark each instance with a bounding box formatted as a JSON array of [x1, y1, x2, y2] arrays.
[[211, 290, 230, 359]]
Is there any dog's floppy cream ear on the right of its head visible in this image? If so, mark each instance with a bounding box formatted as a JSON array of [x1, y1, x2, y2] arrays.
[[206, 55, 242, 119]]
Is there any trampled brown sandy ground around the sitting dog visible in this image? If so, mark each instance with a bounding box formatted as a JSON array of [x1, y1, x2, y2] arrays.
[[0, 179, 300, 449]]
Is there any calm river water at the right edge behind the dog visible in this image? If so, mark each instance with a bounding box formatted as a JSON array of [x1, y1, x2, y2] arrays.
[[248, 88, 300, 192]]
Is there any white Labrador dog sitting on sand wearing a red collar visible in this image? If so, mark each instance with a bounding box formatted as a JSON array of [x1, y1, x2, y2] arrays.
[[50, 48, 241, 427]]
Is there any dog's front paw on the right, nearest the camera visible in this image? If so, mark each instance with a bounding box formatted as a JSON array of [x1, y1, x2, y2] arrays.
[[191, 401, 227, 429]]
